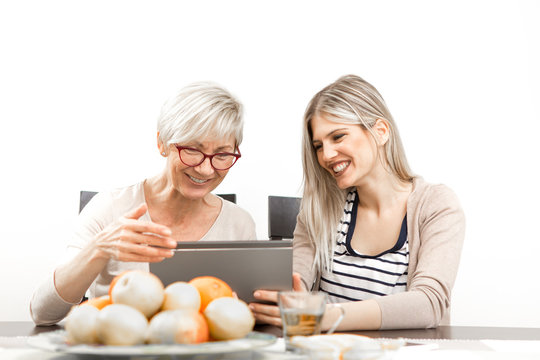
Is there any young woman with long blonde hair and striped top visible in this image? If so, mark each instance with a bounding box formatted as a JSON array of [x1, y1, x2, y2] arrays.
[[251, 75, 465, 330]]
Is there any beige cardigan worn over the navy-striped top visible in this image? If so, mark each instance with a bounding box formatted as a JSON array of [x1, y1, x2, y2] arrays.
[[293, 177, 465, 329]]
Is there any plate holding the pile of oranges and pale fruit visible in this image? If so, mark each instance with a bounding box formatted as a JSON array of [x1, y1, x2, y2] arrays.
[[28, 330, 276, 356]]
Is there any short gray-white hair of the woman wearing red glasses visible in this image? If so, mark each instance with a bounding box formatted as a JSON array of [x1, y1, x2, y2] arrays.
[[157, 82, 244, 146]]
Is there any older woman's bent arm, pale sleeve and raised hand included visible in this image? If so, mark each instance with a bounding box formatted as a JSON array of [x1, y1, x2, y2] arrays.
[[30, 200, 176, 325]]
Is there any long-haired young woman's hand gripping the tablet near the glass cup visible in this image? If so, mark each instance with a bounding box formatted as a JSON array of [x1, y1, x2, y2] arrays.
[[249, 273, 305, 326]]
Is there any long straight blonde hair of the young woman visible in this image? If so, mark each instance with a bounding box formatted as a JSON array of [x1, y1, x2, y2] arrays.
[[300, 75, 414, 271]]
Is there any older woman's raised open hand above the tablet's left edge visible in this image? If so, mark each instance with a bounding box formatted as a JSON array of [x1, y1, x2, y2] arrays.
[[94, 204, 176, 262]]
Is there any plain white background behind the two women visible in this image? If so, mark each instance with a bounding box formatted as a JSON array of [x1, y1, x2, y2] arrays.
[[0, 0, 540, 327]]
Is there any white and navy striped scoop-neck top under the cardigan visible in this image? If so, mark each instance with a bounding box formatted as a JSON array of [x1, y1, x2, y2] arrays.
[[319, 190, 409, 302]]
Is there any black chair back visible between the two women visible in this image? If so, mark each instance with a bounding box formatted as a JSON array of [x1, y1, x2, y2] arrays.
[[268, 196, 302, 240]]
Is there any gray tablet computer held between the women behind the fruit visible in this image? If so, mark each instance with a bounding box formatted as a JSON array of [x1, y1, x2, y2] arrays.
[[150, 240, 292, 303]]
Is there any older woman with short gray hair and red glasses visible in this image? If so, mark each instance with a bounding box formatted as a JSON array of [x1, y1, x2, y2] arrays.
[[30, 83, 256, 325]]
